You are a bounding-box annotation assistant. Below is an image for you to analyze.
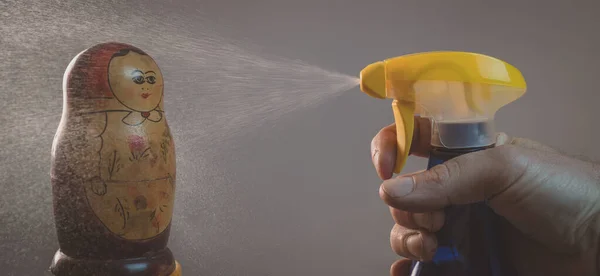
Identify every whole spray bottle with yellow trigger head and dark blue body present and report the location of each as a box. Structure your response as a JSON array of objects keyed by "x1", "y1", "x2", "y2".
[{"x1": 360, "y1": 52, "x2": 527, "y2": 276}]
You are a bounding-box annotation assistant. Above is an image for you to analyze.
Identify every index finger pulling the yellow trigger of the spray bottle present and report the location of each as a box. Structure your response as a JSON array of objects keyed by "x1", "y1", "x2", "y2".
[{"x1": 371, "y1": 116, "x2": 431, "y2": 180}]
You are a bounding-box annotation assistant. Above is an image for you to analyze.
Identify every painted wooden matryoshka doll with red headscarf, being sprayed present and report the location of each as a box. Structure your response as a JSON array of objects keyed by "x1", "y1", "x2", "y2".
[{"x1": 50, "y1": 43, "x2": 181, "y2": 276}]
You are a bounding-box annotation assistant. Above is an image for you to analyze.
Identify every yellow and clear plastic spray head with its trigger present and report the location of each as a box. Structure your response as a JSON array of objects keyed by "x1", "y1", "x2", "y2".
[{"x1": 360, "y1": 52, "x2": 527, "y2": 173}]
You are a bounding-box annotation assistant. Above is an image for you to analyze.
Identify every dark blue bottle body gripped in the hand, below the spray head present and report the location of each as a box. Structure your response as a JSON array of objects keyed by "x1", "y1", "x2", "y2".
[{"x1": 411, "y1": 147, "x2": 517, "y2": 276}]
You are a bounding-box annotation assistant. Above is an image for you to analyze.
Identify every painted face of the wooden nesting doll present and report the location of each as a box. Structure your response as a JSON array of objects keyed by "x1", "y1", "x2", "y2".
[{"x1": 108, "y1": 50, "x2": 164, "y2": 112}]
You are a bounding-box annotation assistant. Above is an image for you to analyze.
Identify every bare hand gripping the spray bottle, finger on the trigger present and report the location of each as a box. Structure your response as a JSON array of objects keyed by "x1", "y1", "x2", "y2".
[{"x1": 371, "y1": 117, "x2": 600, "y2": 276}]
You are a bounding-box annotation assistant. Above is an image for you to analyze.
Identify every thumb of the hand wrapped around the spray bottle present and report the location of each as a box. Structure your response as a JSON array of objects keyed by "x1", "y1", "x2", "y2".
[{"x1": 379, "y1": 145, "x2": 527, "y2": 212}]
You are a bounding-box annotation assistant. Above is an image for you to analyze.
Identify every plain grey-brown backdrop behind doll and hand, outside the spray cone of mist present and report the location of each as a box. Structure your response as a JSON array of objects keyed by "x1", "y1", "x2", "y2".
[{"x1": 0, "y1": 0, "x2": 600, "y2": 276}]
